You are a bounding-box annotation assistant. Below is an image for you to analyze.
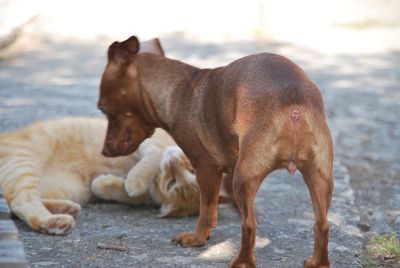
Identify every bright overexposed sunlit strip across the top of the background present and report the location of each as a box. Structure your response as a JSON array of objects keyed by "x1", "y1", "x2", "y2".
[{"x1": 0, "y1": 0, "x2": 400, "y2": 53}]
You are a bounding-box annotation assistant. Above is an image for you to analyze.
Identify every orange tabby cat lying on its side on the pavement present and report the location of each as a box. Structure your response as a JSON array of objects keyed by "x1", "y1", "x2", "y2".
[{"x1": 0, "y1": 118, "x2": 199, "y2": 235}]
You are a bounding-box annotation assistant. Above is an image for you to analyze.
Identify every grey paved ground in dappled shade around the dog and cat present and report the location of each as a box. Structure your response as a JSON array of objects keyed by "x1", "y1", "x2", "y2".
[{"x1": 0, "y1": 35, "x2": 400, "y2": 267}]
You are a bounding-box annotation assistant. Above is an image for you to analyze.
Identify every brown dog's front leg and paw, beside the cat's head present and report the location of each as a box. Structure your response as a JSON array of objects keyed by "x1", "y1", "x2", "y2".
[{"x1": 172, "y1": 166, "x2": 222, "y2": 247}]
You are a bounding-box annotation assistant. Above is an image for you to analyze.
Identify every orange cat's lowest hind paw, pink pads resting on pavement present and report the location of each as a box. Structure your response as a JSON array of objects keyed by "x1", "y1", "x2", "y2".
[{"x1": 40, "y1": 214, "x2": 75, "y2": 235}]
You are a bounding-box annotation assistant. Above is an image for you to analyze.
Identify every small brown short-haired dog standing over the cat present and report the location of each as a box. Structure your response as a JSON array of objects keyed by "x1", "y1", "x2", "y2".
[{"x1": 98, "y1": 36, "x2": 333, "y2": 267}]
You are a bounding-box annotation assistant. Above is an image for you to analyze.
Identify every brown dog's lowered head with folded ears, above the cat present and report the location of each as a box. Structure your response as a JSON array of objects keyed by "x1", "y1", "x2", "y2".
[{"x1": 98, "y1": 36, "x2": 164, "y2": 157}]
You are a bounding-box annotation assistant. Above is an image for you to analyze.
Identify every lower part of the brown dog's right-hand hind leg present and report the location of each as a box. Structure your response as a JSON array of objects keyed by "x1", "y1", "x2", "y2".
[{"x1": 301, "y1": 161, "x2": 333, "y2": 268}]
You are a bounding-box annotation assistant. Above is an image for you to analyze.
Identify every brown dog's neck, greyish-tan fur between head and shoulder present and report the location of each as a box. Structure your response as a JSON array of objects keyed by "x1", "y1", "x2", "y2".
[{"x1": 138, "y1": 53, "x2": 205, "y2": 129}]
